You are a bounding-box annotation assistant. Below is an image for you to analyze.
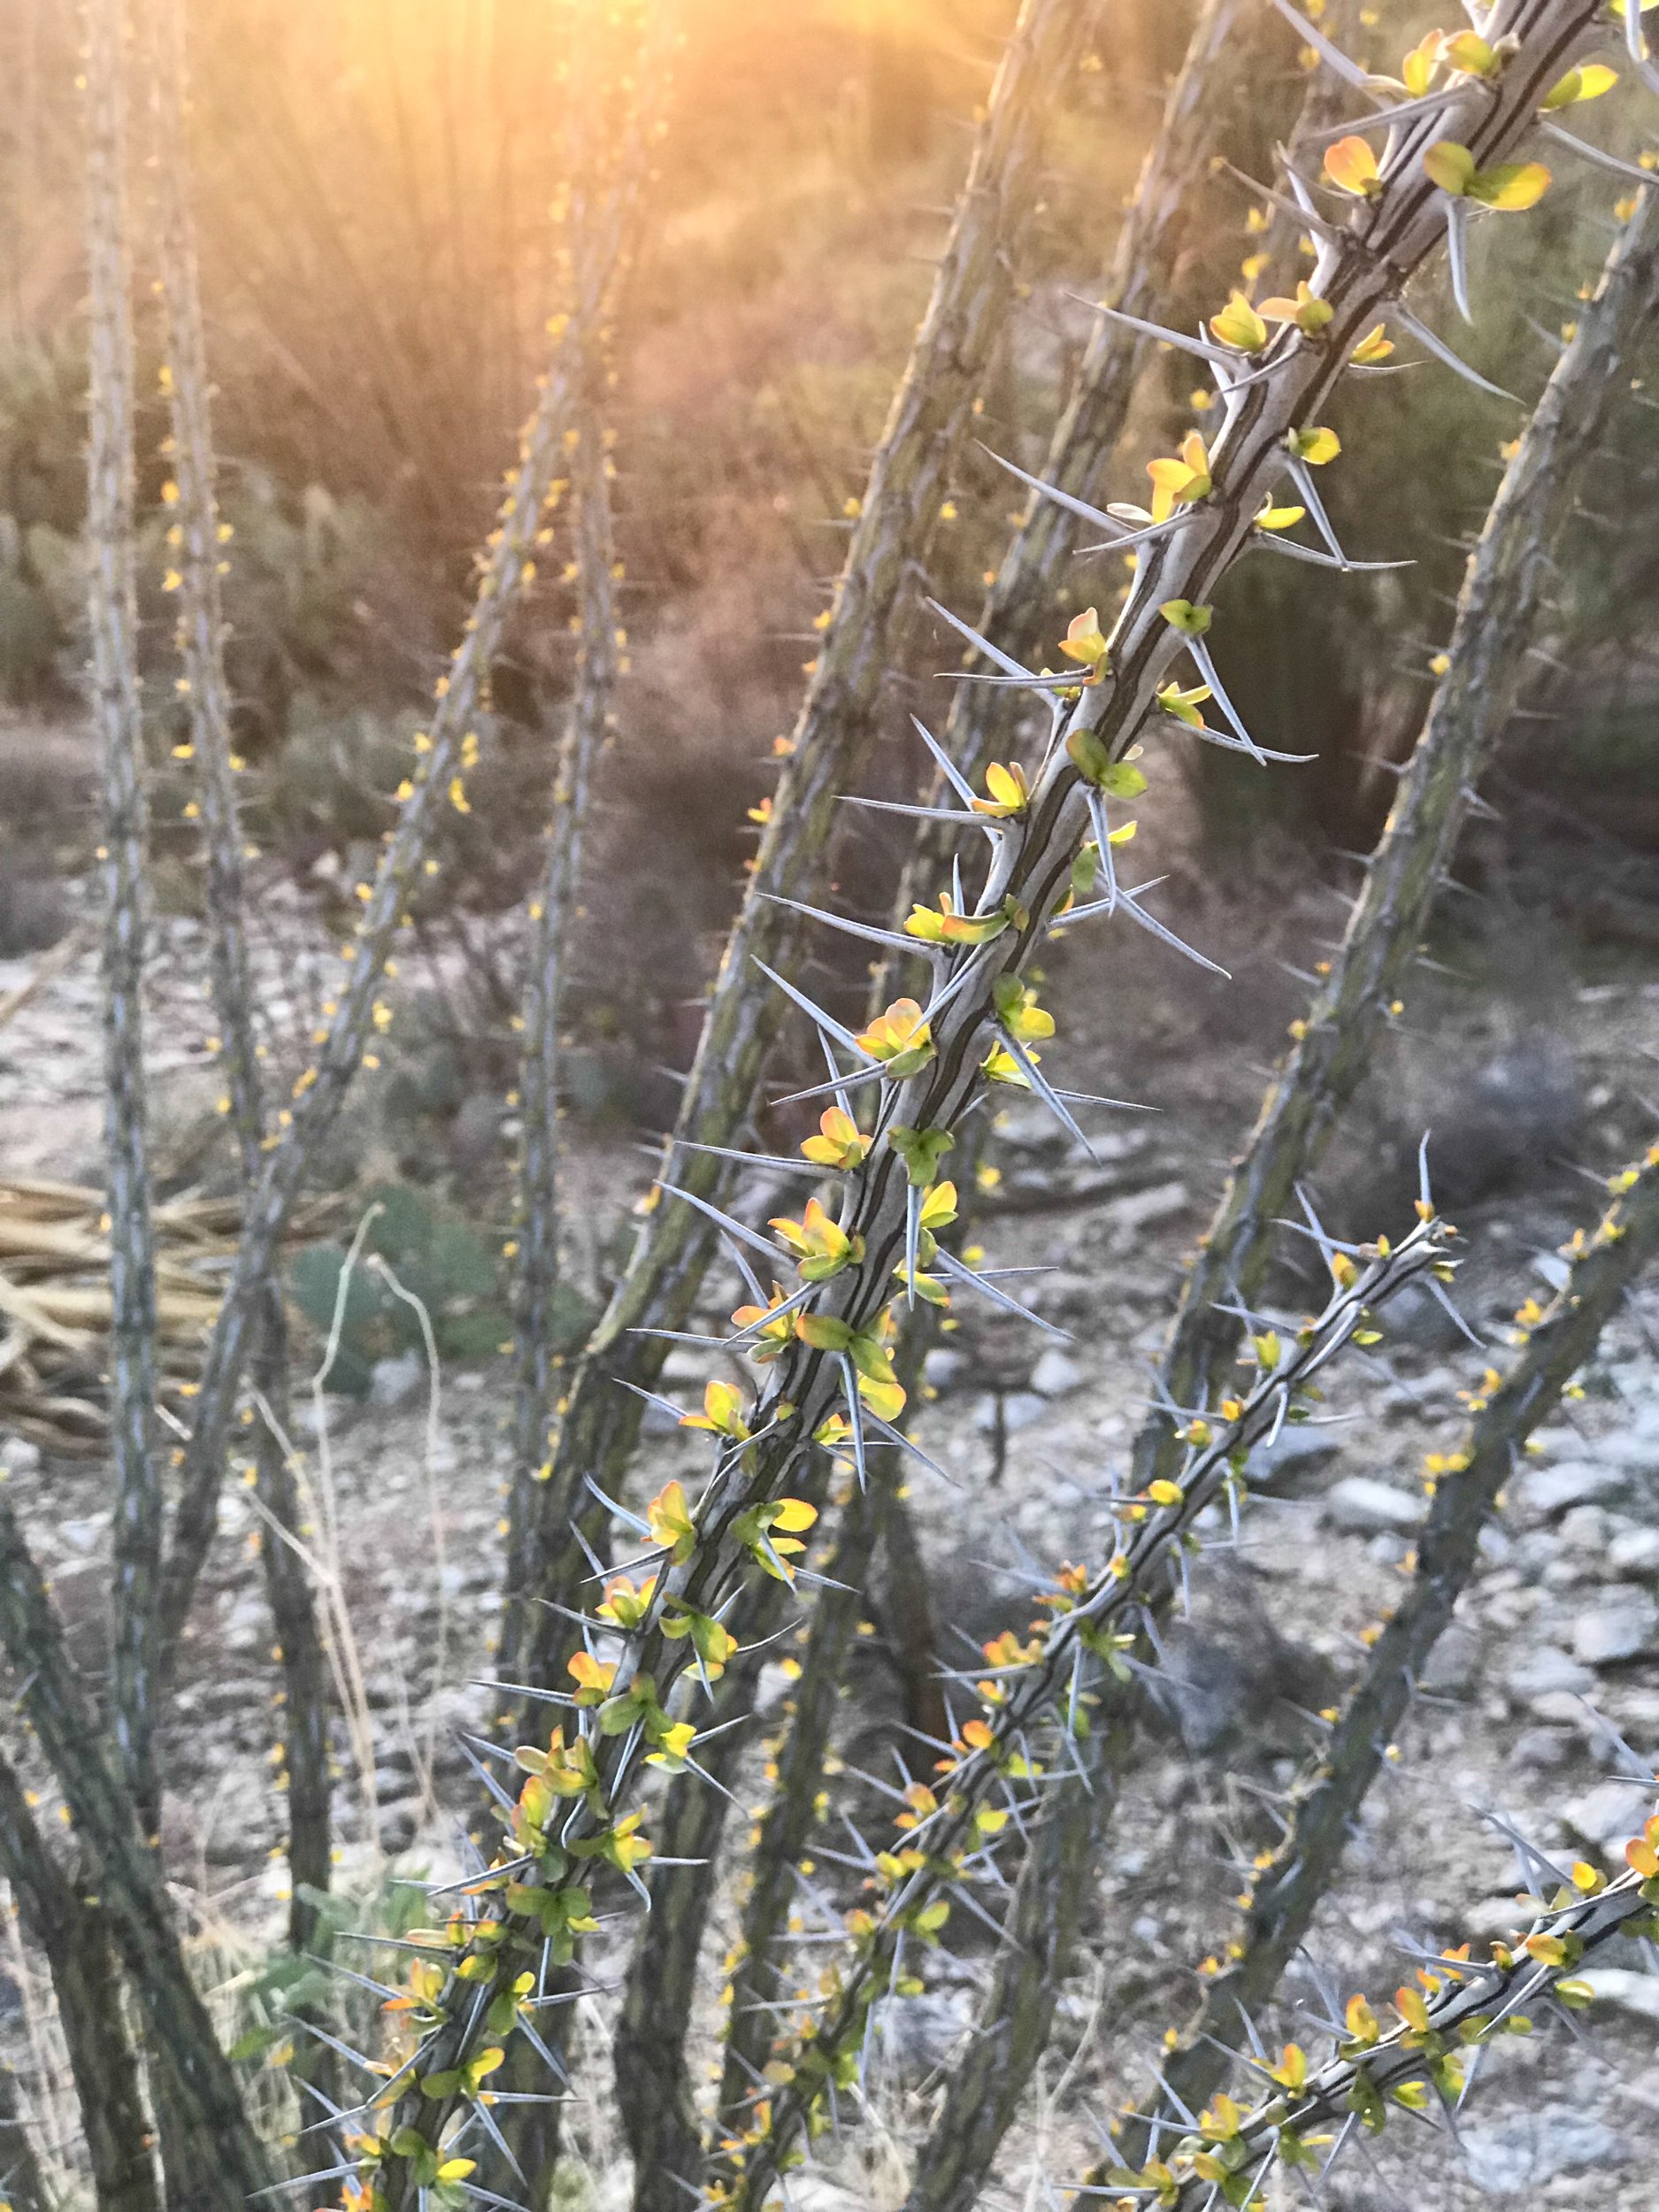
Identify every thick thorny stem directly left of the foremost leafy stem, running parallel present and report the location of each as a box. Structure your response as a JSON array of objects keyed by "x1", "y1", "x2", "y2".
[{"x1": 500, "y1": 0, "x2": 1110, "y2": 1686}]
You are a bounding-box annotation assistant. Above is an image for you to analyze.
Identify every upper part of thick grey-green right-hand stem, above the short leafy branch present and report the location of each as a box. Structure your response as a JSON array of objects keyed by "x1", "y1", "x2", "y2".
[{"x1": 1135, "y1": 177, "x2": 1659, "y2": 1478}]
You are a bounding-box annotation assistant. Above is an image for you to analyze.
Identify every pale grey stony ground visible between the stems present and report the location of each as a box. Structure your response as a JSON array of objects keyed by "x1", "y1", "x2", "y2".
[{"x1": 0, "y1": 889, "x2": 1659, "y2": 2212}]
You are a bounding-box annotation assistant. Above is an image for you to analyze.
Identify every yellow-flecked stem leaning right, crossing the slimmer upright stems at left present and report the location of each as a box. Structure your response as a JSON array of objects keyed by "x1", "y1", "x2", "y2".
[{"x1": 162, "y1": 8, "x2": 664, "y2": 1657}]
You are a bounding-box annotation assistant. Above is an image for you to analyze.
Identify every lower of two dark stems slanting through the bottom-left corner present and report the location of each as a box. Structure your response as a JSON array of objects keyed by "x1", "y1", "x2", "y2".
[{"x1": 0, "y1": 1752, "x2": 162, "y2": 2212}]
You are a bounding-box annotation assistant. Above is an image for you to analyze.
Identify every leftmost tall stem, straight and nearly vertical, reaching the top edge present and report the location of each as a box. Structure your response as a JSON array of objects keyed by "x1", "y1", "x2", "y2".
[{"x1": 87, "y1": 0, "x2": 162, "y2": 1827}]
